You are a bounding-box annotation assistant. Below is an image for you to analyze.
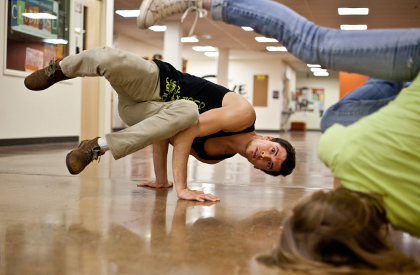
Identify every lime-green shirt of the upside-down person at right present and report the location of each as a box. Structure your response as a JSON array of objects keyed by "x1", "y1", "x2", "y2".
[{"x1": 318, "y1": 74, "x2": 420, "y2": 237}]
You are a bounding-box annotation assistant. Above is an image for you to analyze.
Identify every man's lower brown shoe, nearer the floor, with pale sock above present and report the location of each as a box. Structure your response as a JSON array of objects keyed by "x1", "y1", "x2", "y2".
[{"x1": 66, "y1": 137, "x2": 104, "y2": 175}]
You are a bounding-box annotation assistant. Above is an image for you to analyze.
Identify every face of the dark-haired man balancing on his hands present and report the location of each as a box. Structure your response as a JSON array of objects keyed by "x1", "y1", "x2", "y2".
[{"x1": 245, "y1": 136, "x2": 287, "y2": 172}]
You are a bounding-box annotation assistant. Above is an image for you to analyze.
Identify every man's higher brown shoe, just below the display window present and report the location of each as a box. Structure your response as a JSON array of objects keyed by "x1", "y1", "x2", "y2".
[{"x1": 24, "y1": 59, "x2": 71, "y2": 91}]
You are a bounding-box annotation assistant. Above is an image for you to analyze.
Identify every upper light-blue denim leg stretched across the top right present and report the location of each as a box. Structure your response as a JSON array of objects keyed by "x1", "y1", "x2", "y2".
[{"x1": 211, "y1": 0, "x2": 420, "y2": 81}]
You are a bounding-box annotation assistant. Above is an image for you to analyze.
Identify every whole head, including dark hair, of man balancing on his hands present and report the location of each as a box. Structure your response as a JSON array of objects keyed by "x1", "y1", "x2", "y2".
[{"x1": 246, "y1": 136, "x2": 296, "y2": 176}]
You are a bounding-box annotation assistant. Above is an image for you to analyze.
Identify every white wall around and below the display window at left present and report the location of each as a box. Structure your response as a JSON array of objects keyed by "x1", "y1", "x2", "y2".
[{"x1": 0, "y1": 1, "x2": 81, "y2": 139}]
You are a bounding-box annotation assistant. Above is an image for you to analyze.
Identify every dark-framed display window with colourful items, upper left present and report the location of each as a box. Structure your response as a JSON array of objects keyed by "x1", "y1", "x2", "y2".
[{"x1": 6, "y1": 0, "x2": 70, "y2": 72}]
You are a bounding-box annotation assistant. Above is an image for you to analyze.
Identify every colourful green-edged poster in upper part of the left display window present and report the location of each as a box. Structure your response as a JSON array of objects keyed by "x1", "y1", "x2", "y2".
[{"x1": 10, "y1": 0, "x2": 59, "y2": 39}]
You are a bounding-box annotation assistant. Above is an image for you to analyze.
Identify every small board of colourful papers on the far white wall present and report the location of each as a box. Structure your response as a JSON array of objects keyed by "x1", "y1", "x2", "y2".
[{"x1": 292, "y1": 88, "x2": 325, "y2": 116}]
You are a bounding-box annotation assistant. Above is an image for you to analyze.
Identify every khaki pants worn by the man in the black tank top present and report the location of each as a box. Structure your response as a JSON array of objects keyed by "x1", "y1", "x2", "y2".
[{"x1": 61, "y1": 47, "x2": 199, "y2": 159}]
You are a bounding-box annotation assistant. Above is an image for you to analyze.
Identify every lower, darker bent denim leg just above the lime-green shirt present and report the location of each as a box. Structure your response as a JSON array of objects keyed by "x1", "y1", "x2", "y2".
[{"x1": 320, "y1": 78, "x2": 403, "y2": 132}]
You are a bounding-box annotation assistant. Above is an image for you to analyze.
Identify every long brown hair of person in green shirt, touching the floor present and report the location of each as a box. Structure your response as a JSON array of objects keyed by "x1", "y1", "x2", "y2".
[{"x1": 258, "y1": 188, "x2": 420, "y2": 273}]
